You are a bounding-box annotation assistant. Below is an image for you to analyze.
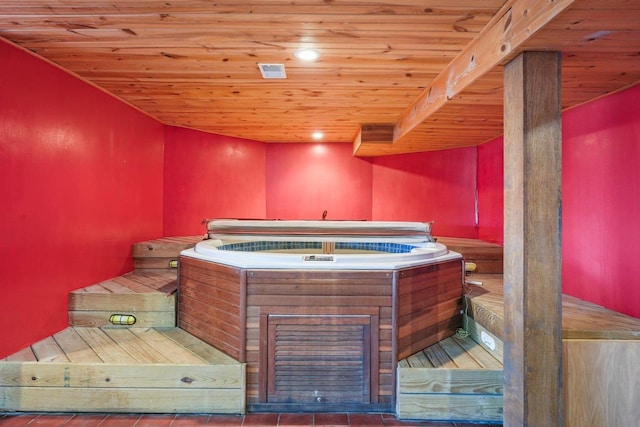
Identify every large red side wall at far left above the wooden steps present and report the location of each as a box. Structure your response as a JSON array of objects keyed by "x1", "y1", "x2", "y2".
[{"x1": 0, "y1": 41, "x2": 163, "y2": 358}]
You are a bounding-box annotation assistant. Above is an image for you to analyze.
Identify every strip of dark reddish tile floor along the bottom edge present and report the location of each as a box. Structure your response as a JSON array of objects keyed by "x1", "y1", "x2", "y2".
[{"x1": 0, "y1": 413, "x2": 500, "y2": 427}]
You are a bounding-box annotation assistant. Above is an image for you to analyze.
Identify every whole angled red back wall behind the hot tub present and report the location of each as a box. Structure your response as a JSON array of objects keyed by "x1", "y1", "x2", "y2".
[{"x1": 164, "y1": 139, "x2": 477, "y2": 232}]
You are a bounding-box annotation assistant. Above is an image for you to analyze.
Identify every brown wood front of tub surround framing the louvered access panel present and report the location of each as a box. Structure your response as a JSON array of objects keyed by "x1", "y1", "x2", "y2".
[{"x1": 246, "y1": 270, "x2": 395, "y2": 410}]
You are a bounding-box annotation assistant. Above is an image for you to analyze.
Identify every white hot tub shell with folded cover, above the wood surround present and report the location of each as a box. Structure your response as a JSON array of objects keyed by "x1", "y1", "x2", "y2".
[{"x1": 182, "y1": 220, "x2": 460, "y2": 270}]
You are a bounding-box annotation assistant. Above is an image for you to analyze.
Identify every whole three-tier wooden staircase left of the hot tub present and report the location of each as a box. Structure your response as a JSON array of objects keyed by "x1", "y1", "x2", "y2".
[{"x1": 0, "y1": 237, "x2": 246, "y2": 414}]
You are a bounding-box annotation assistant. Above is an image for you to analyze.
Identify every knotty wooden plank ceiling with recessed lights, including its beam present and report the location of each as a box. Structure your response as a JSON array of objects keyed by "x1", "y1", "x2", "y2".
[{"x1": 0, "y1": 0, "x2": 640, "y2": 156}]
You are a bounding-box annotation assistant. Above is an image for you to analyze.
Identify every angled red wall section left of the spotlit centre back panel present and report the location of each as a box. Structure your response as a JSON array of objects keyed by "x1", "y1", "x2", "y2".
[{"x1": 164, "y1": 126, "x2": 266, "y2": 236}]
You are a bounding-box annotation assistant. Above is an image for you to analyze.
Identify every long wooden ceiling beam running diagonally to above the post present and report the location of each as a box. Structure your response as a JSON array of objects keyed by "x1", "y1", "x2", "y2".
[{"x1": 354, "y1": 0, "x2": 576, "y2": 155}]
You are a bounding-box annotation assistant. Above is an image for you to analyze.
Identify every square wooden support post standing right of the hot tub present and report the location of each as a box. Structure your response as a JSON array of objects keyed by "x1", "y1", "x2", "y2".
[{"x1": 504, "y1": 52, "x2": 563, "y2": 426}]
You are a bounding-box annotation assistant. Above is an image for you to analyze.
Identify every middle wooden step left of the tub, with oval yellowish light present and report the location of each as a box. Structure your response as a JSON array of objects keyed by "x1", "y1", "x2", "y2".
[{"x1": 68, "y1": 271, "x2": 178, "y2": 328}]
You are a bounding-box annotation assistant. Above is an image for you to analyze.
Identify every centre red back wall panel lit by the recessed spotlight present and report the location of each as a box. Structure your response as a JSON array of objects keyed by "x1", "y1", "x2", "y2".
[{"x1": 266, "y1": 143, "x2": 371, "y2": 220}]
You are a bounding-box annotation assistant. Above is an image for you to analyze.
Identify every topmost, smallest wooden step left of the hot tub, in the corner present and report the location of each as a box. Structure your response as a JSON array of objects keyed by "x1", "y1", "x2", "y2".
[{"x1": 132, "y1": 236, "x2": 204, "y2": 271}]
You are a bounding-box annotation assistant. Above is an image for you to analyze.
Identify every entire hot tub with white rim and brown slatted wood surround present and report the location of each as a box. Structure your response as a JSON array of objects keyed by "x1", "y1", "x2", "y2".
[{"x1": 178, "y1": 221, "x2": 463, "y2": 412}]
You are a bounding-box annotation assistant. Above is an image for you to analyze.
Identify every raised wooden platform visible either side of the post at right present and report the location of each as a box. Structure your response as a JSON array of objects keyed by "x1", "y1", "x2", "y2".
[{"x1": 466, "y1": 275, "x2": 640, "y2": 427}]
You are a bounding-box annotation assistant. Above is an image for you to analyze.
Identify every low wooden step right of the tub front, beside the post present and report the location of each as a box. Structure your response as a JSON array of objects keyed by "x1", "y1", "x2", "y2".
[{"x1": 396, "y1": 336, "x2": 503, "y2": 422}]
